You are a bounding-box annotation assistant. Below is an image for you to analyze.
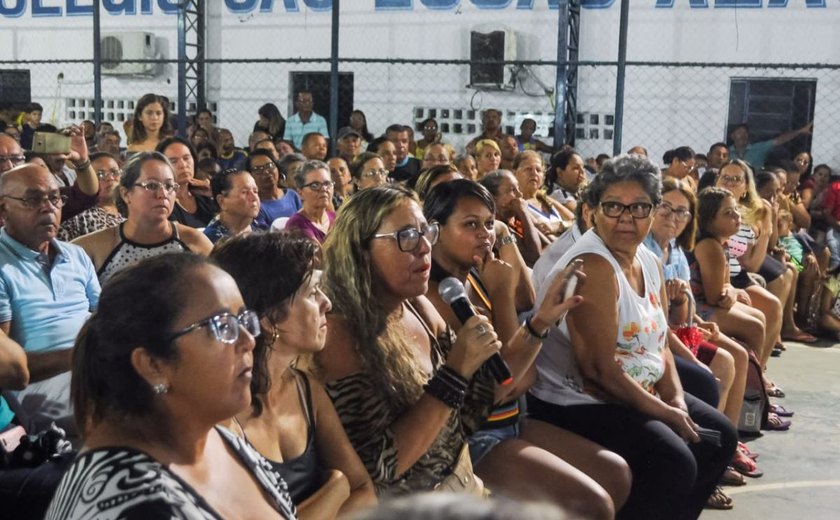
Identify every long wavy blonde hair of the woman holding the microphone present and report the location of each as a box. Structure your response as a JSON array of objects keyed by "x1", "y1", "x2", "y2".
[{"x1": 316, "y1": 186, "x2": 426, "y2": 410}]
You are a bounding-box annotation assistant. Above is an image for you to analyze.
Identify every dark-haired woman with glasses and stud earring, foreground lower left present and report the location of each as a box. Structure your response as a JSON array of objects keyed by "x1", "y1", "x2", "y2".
[{"x1": 46, "y1": 254, "x2": 296, "y2": 520}]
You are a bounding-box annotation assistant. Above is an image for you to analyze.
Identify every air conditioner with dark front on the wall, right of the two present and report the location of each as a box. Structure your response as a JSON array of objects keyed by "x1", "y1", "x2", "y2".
[{"x1": 469, "y1": 30, "x2": 516, "y2": 88}]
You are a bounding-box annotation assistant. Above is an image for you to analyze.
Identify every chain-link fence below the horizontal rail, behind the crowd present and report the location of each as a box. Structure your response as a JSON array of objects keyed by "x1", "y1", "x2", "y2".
[{"x1": 0, "y1": 55, "x2": 840, "y2": 163}]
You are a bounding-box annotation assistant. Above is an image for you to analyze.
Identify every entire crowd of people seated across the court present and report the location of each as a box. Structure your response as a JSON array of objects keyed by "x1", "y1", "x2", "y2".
[{"x1": 0, "y1": 92, "x2": 828, "y2": 519}]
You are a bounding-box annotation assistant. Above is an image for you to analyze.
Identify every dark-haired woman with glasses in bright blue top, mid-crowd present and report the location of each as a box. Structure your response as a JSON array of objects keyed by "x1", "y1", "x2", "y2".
[{"x1": 245, "y1": 150, "x2": 303, "y2": 230}]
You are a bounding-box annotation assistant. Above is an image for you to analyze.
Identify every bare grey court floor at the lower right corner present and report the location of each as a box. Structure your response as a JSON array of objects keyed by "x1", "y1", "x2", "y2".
[{"x1": 701, "y1": 341, "x2": 840, "y2": 520}]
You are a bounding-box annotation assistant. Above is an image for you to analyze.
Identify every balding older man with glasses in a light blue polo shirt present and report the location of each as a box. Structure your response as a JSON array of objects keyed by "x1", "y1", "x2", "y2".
[{"x1": 0, "y1": 160, "x2": 100, "y2": 437}]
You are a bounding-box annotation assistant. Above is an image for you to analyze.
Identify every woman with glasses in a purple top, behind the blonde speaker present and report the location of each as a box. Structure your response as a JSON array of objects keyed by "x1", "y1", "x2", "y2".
[{"x1": 286, "y1": 161, "x2": 335, "y2": 244}]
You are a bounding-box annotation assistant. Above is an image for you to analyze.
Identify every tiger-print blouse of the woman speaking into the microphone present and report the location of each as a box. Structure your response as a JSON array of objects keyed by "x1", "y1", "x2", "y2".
[{"x1": 326, "y1": 304, "x2": 496, "y2": 494}]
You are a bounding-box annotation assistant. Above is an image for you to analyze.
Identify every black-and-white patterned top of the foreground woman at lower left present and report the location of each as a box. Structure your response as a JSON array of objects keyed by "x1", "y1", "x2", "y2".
[{"x1": 45, "y1": 426, "x2": 297, "y2": 520}]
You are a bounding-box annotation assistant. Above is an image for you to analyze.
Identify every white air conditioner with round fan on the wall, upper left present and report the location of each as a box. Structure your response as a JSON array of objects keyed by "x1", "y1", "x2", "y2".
[{"x1": 99, "y1": 32, "x2": 157, "y2": 76}]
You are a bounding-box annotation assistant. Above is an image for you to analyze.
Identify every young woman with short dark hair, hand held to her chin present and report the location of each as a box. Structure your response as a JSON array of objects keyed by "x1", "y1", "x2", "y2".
[{"x1": 423, "y1": 177, "x2": 630, "y2": 518}]
